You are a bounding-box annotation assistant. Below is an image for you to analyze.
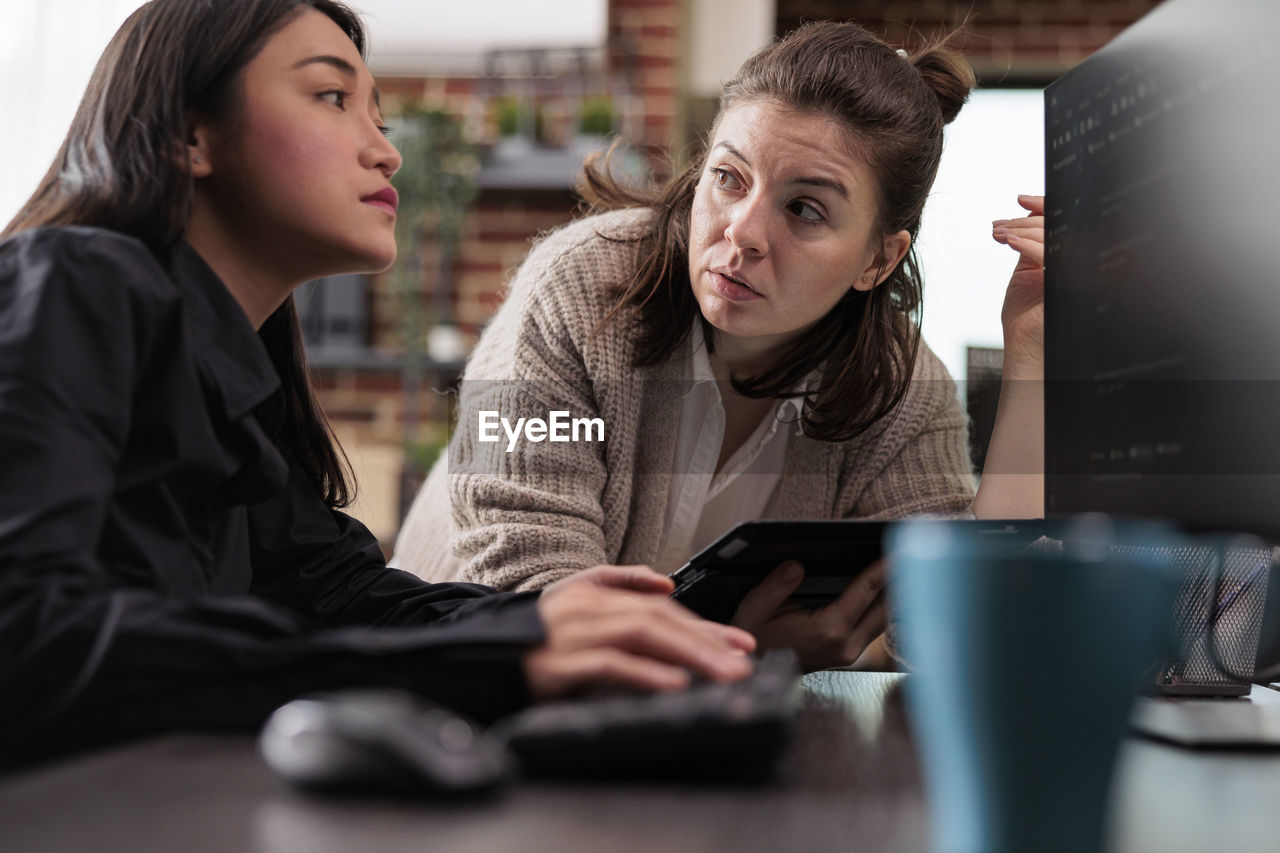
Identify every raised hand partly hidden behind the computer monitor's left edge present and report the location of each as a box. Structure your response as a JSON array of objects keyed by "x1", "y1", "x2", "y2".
[{"x1": 991, "y1": 196, "x2": 1044, "y2": 379}]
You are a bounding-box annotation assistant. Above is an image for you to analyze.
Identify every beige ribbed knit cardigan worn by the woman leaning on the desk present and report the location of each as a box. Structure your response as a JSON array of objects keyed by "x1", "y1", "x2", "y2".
[{"x1": 393, "y1": 210, "x2": 974, "y2": 589}]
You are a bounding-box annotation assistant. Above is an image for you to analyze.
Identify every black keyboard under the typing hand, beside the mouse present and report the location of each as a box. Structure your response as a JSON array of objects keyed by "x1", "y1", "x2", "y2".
[{"x1": 492, "y1": 649, "x2": 800, "y2": 781}]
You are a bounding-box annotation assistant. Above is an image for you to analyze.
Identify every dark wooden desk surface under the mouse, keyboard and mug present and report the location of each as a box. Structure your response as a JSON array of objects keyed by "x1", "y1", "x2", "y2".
[{"x1": 0, "y1": 672, "x2": 1280, "y2": 853}]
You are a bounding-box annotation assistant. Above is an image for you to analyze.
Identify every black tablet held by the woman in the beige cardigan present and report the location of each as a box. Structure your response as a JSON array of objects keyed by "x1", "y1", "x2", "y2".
[{"x1": 671, "y1": 519, "x2": 1042, "y2": 622}]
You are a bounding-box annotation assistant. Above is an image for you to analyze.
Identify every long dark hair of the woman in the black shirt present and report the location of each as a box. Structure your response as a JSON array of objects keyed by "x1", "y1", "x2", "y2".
[{"x1": 0, "y1": 0, "x2": 365, "y2": 506}]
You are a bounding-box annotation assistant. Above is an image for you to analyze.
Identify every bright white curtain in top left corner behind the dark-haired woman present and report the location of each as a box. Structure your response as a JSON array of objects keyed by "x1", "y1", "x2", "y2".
[{"x1": 0, "y1": 0, "x2": 142, "y2": 225}]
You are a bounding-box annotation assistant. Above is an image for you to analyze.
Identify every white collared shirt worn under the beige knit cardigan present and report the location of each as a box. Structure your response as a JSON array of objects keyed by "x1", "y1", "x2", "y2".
[{"x1": 655, "y1": 318, "x2": 801, "y2": 573}]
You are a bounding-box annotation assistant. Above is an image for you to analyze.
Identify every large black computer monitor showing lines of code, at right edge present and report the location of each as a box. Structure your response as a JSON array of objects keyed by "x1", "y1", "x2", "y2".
[{"x1": 1044, "y1": 0, "x2": 1280, "y2": 540}]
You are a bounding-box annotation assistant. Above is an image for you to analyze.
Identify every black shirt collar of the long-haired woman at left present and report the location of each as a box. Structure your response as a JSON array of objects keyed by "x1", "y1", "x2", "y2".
[{"x1": 168, "y1": 242, "x2": 280, "y2": 420}]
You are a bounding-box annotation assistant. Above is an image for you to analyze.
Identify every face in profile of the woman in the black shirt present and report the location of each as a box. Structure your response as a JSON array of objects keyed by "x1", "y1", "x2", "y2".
[{"x1": 192, "y1": 9, "x2": 401, "y2": 280}]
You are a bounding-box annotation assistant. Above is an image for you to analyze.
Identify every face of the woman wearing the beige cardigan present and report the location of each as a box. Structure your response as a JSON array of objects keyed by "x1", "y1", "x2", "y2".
[{"x1": 689, "y1": 101, "x2": 910, "y2": 343}]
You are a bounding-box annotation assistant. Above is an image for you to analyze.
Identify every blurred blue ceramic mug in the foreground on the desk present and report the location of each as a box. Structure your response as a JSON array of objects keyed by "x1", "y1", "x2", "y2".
[{"x1": 888, "y1": 516, "x2": 1178, "y2": 853}]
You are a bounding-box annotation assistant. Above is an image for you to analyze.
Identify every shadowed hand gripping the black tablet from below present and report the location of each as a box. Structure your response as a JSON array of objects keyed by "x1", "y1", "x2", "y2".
[{"x1": 733, "y1": 560, "x2": 888, "y2": 670}]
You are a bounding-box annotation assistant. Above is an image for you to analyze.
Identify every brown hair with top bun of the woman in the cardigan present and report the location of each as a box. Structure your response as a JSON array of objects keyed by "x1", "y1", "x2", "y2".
[{"x1": 581, "y1": 22, "x2": 974, "y2": 441}]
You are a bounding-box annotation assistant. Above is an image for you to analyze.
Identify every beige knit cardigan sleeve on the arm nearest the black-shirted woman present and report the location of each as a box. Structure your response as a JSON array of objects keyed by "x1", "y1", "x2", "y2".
[{"x1": 442, "y1": 220, "x2": 640, "y2": 589}]
